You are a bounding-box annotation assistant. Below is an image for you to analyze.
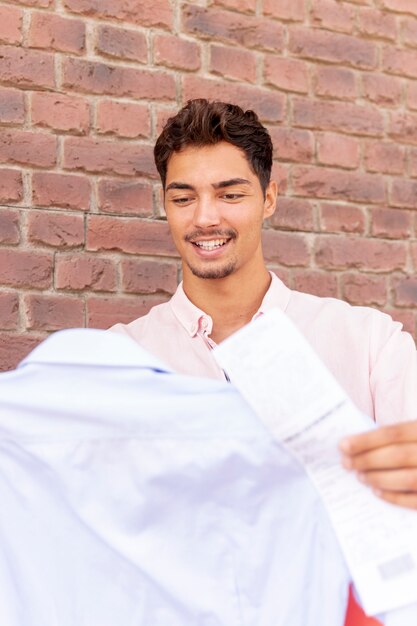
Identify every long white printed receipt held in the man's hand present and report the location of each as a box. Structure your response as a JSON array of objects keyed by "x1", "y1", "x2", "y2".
[{"x1": 214, "y1": 310, "x2": 417, "y2": 626}]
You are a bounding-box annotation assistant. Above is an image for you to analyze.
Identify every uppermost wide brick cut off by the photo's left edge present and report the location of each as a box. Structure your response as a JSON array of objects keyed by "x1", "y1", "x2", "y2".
[{"x1": 0, "y1": 46, "x2": 55, "y2": 88}]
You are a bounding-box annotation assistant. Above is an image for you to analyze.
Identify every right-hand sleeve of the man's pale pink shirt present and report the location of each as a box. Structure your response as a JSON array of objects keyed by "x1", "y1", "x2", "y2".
[{"x1": 370, "y1": 314, "x2": 417, "y2": 425}]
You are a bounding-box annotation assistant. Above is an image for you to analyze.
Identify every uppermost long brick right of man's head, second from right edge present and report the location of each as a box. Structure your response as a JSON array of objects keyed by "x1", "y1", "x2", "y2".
[{"x1": 289, "y1": 26, "x2": 377, "y2": 69}]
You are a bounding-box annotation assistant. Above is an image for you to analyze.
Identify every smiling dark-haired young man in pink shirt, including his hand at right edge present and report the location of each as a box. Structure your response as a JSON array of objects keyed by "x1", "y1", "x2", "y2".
[{"x1": 112, "y1": 100, "x2": 417, "y2": 509}]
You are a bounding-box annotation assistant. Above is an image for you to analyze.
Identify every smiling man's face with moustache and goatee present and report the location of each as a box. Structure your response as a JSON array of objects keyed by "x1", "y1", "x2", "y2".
[{"x1": 165, "y1": 141, "x2": 276, "y2": 279}]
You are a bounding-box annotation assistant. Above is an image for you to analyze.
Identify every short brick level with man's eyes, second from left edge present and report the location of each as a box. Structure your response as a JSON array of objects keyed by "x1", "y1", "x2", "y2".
[{"x1": 32, "y1": 172, "x2": 91, "y2": 211}]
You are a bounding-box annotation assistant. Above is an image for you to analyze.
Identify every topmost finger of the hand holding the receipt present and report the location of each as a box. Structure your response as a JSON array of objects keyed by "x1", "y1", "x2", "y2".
[{"x1": 340, "y1": 421, "x2": 417, "y2": 456}]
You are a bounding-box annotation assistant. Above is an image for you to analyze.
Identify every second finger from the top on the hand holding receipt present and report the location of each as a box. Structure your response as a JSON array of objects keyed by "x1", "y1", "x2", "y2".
[{"x1": 342, "y1": 443, "x2": 417, "y2": 472}]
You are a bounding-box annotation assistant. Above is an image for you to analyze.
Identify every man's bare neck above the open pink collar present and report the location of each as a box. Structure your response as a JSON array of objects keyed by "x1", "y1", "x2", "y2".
[{"x1": 183, "y1": 266, "x2": 271, "y2": 343}]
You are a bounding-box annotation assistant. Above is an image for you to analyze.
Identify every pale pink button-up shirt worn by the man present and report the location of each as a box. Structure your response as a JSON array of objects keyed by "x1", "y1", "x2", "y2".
[{"x1": 111, "y1": 274, "x2": 417, "y2": 424}]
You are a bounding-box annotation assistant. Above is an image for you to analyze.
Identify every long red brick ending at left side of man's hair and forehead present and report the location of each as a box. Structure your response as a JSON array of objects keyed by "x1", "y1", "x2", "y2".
[{"x1": 64, "y1": 137, "x2": 156, "y2": 177}]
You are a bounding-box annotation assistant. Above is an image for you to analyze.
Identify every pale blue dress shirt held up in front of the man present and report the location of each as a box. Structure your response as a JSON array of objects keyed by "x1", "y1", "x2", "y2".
[{"x1": 0, "y1": 330, "x2": 349, "y2": 626}]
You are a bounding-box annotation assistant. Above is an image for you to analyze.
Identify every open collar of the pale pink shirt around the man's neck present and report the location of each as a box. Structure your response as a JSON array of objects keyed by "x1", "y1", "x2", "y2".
[{"x1": 170, "y1": 272, "x2": 291, "y2": 337}]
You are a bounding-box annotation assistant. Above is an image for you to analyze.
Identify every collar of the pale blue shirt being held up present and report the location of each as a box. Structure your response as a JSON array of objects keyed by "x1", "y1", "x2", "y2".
[{"x1": 19, "y1": 328, "x2": 172, "y2": 372}]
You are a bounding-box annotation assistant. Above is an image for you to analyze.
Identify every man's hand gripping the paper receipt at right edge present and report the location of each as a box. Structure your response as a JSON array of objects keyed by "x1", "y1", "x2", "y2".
[{"x1": 340, "y1": 422, "x2": 417, "y2": 509}]
